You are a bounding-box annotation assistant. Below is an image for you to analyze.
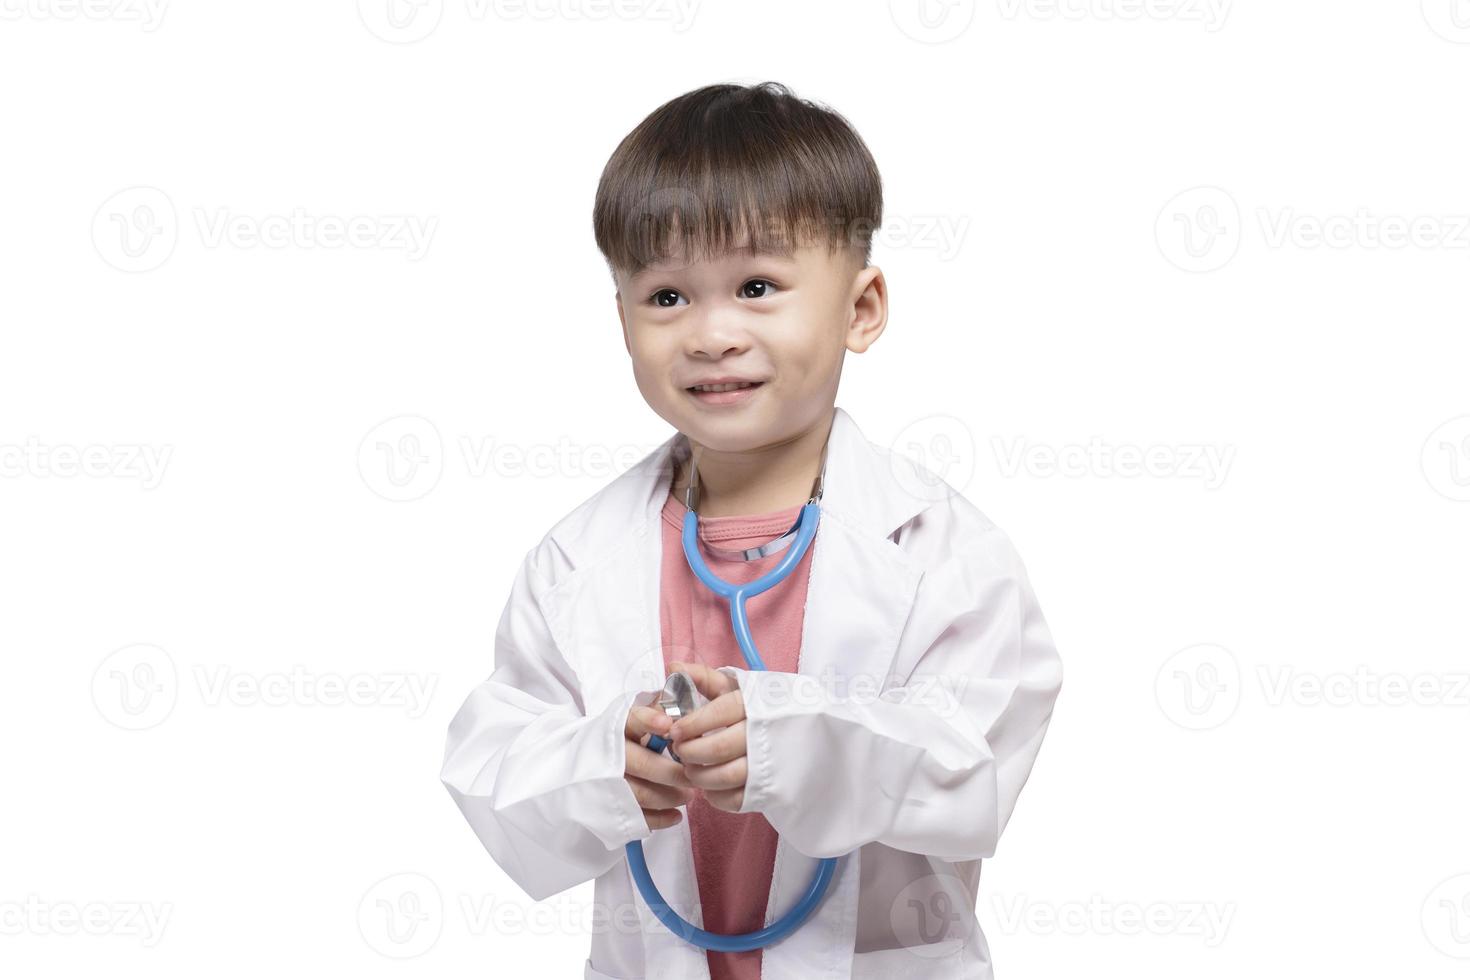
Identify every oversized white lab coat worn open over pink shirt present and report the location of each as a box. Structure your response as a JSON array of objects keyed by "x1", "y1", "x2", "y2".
[{"x1": 441, "y1": 407, "x2": 1061, "y2": 980}]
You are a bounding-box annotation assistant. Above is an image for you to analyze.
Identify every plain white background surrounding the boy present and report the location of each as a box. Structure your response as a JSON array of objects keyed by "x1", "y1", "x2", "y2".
[{"x1": 0, "y1": 0, "x2": 1470, "y2": 980}]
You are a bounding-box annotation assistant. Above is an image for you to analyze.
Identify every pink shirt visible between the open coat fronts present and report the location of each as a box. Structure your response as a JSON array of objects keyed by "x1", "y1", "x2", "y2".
[{"x1": 659, "y1": 492, "x2": 817, "y2": 980}]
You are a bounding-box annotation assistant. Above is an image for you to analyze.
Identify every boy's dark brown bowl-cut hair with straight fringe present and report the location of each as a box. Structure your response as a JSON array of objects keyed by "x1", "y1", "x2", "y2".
[{"x1": 592, "y1": 82, "x2": 883, "y2": 276}]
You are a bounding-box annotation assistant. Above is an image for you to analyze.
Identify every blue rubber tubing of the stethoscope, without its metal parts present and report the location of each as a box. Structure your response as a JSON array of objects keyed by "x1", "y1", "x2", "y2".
[{"x1": 623, "y1": 501, "x2": 836, "y2": 952}]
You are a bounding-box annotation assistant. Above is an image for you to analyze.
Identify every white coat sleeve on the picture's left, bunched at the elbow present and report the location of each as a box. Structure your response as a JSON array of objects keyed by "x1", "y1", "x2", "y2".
[{"x1": 440, "y1": 545, "x2": 651, "y2": 901}]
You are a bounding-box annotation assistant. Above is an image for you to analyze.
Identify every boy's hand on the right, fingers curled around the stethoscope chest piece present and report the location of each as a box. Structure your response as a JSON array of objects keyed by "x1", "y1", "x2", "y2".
[{"x1": 666, "y1": 661, "x2": 747, "y2": 813}]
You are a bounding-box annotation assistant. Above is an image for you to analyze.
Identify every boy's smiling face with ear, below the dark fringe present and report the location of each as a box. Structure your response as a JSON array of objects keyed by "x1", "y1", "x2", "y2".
[{"x1": 617, "y1": 235, "x2": 888, "y2": 453}]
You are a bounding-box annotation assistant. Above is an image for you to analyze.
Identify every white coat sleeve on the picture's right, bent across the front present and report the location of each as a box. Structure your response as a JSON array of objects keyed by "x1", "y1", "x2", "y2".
[{"x1": 722, "y1": 497, "x2": 1061, "y2": 861}]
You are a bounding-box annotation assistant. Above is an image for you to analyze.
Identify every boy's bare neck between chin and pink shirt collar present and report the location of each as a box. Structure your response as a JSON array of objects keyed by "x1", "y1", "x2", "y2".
[{"x1": 673, "y1": 413, "x2": 835, "y2": 517}]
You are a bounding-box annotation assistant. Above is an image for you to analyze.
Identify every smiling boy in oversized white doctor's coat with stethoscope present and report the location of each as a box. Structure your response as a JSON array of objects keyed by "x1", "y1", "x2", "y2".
[{"x1": 442, "y1": 82, "x2": 1061, "y2": 980}]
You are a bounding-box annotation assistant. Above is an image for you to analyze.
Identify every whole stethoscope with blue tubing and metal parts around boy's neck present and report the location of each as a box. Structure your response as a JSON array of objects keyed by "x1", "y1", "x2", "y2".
[{"x1": 623, "y1": 434, "x2": 836, "y2": 952}]
